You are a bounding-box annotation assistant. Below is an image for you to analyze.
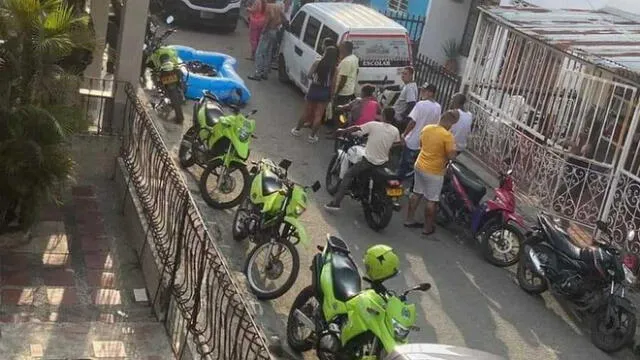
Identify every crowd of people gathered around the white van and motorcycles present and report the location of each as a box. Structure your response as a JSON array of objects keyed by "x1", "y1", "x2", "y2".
[{"x1": 249, "y1": 0, "x2": 472, "y2": 236}]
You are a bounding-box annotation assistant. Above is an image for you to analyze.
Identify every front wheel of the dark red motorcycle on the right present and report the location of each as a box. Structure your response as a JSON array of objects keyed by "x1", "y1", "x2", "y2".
[{"x1": 482, "y1": 223, "x2": 524, "y2": 267}]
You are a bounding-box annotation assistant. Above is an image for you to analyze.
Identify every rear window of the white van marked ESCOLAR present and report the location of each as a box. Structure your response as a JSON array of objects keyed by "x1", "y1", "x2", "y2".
[{"x1": 349, "y1": 34, "x2": 411, "y2": 67}]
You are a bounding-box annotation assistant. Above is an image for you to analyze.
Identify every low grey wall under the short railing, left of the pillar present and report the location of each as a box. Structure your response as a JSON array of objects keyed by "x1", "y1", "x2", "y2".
[{"x1": 71, "y1": 134, "x2": 122, "y2": 182}]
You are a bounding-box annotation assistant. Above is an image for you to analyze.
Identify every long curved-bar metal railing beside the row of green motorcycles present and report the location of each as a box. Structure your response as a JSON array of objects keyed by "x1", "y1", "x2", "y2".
[{"x1": 121, "y1": 84, "x2": 270, "y2": 360}]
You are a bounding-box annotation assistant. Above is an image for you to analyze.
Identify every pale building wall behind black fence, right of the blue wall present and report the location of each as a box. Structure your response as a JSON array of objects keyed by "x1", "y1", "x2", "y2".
[{"x1": 420, "y1": 0, "x2": 471, "y2": 64}]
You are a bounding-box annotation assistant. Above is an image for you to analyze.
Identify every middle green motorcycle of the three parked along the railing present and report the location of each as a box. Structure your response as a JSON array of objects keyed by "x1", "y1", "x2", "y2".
[{"x1": 233, "y1": 159, "x2": 320, "y2": 300}]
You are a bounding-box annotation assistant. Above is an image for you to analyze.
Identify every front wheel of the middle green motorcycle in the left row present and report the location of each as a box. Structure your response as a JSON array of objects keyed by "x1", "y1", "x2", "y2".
[{"x1": 245, "y1": 232, "x2": 300, "y2": 300}]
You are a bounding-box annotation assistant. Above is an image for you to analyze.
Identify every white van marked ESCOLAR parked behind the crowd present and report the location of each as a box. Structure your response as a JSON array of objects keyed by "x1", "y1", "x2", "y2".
[{"x1": 278, "y1": 2, "x2": 412, "y2": 93}]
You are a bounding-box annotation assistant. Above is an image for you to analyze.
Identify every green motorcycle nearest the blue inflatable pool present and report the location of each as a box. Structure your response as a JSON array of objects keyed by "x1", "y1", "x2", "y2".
[{"x1": 188, "y1": 91, "x2": 257, "y2": 209}]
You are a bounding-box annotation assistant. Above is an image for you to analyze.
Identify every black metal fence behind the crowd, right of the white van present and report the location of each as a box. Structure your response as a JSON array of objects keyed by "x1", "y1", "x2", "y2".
[{"x1": 413, "y1": 54, "x2": 462, "y2": 110}]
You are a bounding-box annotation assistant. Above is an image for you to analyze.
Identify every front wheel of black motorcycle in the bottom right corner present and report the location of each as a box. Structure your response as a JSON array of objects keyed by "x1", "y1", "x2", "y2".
[{"x1": 591, "y1": 305, "x2": 636, "y2": 353}]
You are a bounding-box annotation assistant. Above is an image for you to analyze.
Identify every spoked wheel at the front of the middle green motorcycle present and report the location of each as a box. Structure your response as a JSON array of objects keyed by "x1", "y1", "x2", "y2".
[{"x1": 244, "y1": 235, "x2": 300, "y2": 300}]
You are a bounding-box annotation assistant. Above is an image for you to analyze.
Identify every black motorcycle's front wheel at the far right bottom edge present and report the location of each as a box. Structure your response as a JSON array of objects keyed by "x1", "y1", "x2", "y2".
[{"x1": 591, "y1": 306, "x2": 636, "y2": 353}]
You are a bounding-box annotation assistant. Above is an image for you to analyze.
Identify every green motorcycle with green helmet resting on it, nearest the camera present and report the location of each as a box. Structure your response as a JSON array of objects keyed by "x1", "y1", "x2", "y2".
[{"x1": 287, "y1": 236, "x2": 431, "y2": 360}]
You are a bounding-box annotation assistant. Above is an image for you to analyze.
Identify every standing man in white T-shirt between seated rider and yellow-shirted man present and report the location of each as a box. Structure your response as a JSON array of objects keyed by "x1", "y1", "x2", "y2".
[{"x1": 398, "y1": 84, "x2": 442, "y2": 179}]
